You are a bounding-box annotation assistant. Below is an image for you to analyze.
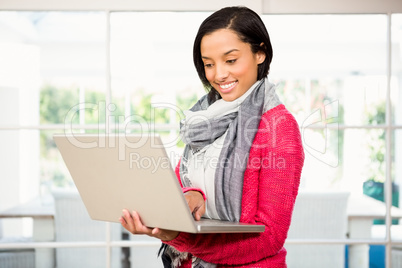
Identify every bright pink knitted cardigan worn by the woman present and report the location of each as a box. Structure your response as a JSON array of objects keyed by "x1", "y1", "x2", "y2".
[{"x1": 163, "y1": 104, "x2": 304, "y2": 268}]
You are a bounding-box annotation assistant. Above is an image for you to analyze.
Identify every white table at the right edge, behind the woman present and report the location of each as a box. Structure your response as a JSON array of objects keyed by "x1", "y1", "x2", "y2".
[{"x1": 347, "y1": 194, "x2": 402, "y2": 268}]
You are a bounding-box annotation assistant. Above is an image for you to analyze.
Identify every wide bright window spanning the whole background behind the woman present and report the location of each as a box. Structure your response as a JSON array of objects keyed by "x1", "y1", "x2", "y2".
[{"x1": 0, "y1": 5, "x2": 402, "y2": 265}]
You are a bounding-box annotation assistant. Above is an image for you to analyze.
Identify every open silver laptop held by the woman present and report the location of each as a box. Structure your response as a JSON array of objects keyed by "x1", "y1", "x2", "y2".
[{"x1": 53, "y1": 134, "x2": 265, "y2": 233}]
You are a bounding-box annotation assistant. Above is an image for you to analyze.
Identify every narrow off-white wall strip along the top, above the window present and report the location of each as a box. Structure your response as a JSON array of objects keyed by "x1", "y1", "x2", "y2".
[{"x1": 0, "y1": 0, "x2": 402, "y2": 13}]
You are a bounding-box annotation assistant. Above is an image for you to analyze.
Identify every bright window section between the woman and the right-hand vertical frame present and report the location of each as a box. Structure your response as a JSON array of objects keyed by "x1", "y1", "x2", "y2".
[{"x1": 264, "y1": 15, "x2": 387, "y2": 193}]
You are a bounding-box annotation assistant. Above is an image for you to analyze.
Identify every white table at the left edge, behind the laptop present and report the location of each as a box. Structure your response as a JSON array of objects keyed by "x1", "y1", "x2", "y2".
[{"x1": 0, "y1": 198, "x2": 55, "y2": 268}]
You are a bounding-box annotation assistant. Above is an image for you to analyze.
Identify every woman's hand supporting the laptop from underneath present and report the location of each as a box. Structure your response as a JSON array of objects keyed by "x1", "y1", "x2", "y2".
[{"x1": 119, "y1": 209, "x2": 179, "y2": 241}]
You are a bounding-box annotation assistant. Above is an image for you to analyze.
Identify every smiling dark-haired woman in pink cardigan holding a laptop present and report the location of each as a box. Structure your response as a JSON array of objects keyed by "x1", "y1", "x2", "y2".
[{"x1": 120, "y1": 7, "x2": 304, "y2": 268}]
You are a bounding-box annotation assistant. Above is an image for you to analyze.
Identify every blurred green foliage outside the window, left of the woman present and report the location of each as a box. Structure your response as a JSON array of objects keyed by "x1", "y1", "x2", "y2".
[{"x1": 39, "y1": 85, "x2": 197, "y2": 187}]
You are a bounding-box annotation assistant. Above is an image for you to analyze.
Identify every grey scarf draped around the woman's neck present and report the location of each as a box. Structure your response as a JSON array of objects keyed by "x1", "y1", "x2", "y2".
[{"x1": 180, "y1": 77, "x2": 265, "y2": 222}]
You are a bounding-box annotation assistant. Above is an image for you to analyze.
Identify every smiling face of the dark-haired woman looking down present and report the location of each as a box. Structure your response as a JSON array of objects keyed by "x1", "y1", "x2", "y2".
[{"x1": 201, "y1": 29, "x2": 265, "y2": 101}]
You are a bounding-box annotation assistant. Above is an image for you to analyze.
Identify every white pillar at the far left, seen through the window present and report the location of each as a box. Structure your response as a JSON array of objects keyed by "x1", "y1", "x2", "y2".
[{"x1": 0, "y1": 43, "x2": 40, "y2": 238}]
